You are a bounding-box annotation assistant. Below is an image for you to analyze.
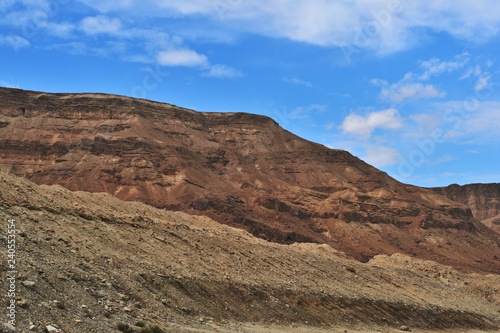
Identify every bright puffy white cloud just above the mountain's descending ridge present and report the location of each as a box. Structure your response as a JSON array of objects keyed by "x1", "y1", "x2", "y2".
[{"x1": 340, "y1": 109, "x2": 403, "y2": 139}]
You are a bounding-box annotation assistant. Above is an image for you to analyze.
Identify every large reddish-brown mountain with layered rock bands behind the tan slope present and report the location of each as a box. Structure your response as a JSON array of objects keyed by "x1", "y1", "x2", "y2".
[{"x1": 0, "y1": 88, "x2": 500, "y2": 273}]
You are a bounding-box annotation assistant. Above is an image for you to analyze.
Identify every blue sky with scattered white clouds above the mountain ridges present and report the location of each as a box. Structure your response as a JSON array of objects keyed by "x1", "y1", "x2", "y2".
[{"x1": 0, "y1": 0, "x2": 500, "y2": 186}]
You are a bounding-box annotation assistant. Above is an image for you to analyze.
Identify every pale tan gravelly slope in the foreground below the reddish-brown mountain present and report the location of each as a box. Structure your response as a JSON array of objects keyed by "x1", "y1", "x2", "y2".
[{"x1": 0, "y1": 173, "x2": 500, "y2": 333}]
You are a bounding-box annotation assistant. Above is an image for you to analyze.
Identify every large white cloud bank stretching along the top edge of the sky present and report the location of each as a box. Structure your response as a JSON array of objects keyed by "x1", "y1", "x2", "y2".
[{"x1": 75, "y1": 0, "x2": 500, "y2": 53}]
